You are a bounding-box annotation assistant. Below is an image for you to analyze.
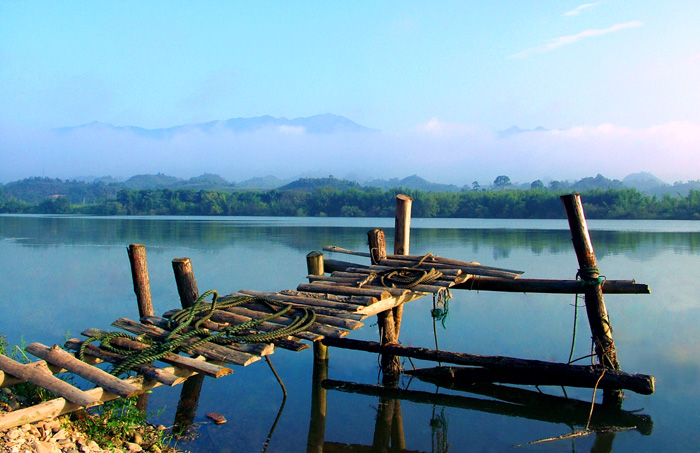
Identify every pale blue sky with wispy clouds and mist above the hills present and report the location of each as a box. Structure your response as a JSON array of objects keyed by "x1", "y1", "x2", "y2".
[{"x1": 0, "y1": 0, "x2": 700, "y2": 185}]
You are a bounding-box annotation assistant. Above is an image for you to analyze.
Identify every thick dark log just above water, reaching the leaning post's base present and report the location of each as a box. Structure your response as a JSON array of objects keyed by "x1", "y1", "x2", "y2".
[{"x1": 323, "y1": 339, "x2": 654, "y2": 395}]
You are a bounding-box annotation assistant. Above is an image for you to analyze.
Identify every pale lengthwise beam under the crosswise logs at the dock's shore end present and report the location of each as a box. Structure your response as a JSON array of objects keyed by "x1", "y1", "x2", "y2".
[{"x1": 0, "y1": 368, "x2": 178, "y2": 430}]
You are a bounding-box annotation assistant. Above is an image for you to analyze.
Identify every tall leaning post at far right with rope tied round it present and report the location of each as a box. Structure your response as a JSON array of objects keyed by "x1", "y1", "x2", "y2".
[{"x1": 561, "y1": 194, "x2": 622, "y2": 402}]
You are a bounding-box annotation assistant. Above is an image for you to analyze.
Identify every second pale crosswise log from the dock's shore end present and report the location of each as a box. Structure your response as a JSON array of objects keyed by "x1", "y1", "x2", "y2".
[{"x1": 25, "y1": 343, "x2": 139, "y2": 398}]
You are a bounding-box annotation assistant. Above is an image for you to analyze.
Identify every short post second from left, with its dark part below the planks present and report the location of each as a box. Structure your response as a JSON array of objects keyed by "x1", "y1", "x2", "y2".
[{"x1": 173, "y1": 258, "x2": 204, "y2": 432}]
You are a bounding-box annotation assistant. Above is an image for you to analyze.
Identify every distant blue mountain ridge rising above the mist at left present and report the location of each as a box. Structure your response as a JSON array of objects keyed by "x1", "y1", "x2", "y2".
[{"x1": 55, "y1": 113, "x2": 376, "y2": 139}]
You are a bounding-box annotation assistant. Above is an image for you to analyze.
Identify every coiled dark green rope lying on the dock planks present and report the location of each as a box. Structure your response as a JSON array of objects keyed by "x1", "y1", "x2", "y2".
[{"x1": 79, "y1": 290, "x2": 316, "y2": 376}]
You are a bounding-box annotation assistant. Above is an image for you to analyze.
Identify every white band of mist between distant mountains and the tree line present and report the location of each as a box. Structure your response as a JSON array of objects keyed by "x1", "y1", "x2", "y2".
[{"x1": 0, "y1": 119, "x2": 700, "y2": 186}]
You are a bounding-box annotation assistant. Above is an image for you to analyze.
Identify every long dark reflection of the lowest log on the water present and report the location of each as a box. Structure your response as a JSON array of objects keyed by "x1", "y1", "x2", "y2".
[{"x1": 323, "y1": 379, "x2": 653, "y2": 435}]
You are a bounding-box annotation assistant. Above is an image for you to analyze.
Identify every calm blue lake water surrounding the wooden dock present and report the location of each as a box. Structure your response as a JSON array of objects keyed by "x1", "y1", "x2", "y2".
[{"x1": 0, "y1": 216, "x2": 700, "y2": 452}]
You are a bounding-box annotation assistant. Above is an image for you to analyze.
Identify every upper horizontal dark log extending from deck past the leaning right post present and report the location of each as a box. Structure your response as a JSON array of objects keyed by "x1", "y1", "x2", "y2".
[{"x1": 453, "y1": 276, "x2": 651, "y2": 294}]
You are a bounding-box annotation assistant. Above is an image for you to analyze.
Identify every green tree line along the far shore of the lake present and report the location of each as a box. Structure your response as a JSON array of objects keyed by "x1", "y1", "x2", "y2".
[{"x1": 0, "y1": 186, "x2": 700, "y2": 220}]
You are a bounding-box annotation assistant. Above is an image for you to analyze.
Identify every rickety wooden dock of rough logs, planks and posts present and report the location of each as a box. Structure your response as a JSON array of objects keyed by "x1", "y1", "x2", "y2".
[{"x1": 0, "y1": 192, "x2": 654, "y2": 440}]
